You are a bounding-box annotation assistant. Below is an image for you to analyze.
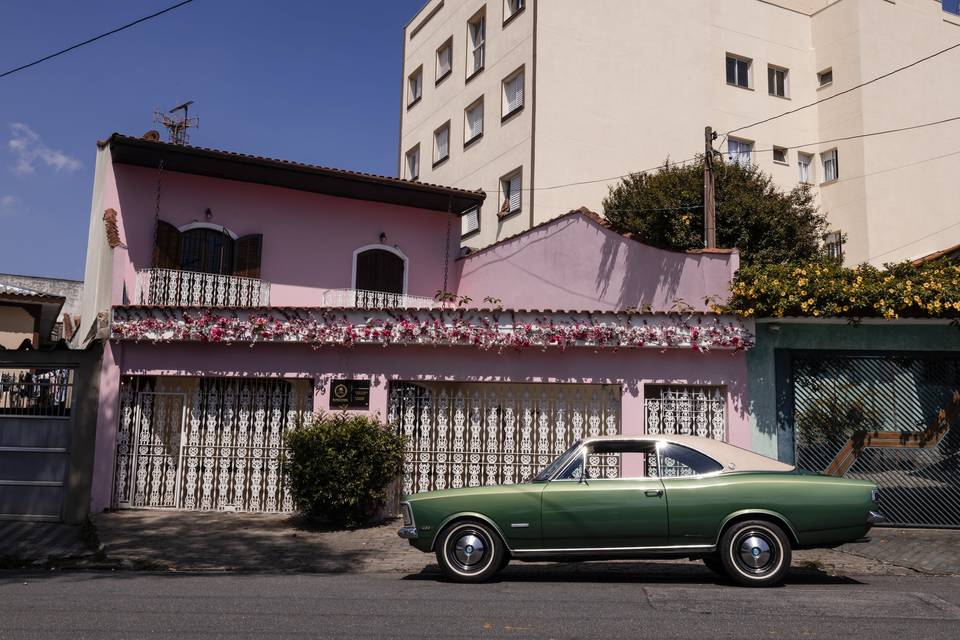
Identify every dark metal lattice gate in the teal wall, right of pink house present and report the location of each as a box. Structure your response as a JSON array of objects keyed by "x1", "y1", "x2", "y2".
[{"x1": 791, "y1": 354, "x2": 960, "y2": 527}]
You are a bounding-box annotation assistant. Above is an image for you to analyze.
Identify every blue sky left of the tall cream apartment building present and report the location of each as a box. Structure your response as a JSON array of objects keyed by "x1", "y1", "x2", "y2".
[{"x1": 0, "y1": 0, "x2": 422, "y2": 279}]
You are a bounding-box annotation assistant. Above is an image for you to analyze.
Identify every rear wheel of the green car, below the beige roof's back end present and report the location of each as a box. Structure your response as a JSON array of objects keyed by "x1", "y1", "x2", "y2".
[{"x1": 719, "y1": 520, "x2": 791, "y2": 587}]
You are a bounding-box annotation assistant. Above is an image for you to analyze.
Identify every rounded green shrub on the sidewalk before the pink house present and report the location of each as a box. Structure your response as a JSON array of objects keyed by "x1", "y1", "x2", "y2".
[{"x1": 283, "y1": 414, "x2": 405, "y2": 526}]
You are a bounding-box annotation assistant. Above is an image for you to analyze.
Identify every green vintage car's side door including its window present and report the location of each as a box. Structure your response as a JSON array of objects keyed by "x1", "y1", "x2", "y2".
[{"x1": 541, "y1": 441, "x2": 668, "y2": 550}]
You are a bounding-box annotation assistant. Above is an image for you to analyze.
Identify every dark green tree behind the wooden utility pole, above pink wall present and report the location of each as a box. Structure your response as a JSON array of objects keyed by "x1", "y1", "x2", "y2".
[{"x1": 603, "y1": 156, "x2": 827, "y2": 263}]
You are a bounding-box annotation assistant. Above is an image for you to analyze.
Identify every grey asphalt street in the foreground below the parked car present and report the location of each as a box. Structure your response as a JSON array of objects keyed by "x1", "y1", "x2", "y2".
[{"x1": 0, "y1": 570, "x2": 960, "y2": 640}]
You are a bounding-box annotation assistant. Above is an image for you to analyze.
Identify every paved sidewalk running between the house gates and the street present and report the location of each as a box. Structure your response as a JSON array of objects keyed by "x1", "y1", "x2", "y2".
[{"x1": 0, "y1": 510, "x2": 960, "y2": 576}]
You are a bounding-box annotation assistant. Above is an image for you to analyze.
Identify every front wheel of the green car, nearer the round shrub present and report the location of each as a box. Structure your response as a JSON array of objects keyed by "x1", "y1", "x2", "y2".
[{"x1": 437, "y1": 520, "x2": 509, "y2": 582}]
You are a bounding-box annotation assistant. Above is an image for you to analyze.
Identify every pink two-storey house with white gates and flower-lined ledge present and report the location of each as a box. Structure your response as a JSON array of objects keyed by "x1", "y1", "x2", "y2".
[{"x1": 77, "y1": 135, "x2": 753, "y2": 511}]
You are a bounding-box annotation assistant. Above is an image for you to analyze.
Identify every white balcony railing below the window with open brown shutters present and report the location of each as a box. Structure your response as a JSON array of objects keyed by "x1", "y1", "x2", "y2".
[{"x1": 137, "y1": 269, "x2": 270, "y2": 307}]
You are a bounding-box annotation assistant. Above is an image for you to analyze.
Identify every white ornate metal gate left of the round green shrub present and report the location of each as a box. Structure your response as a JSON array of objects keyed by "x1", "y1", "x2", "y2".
[{"x1": 114, "y1": 377, "x2": 312, "y2": 511}]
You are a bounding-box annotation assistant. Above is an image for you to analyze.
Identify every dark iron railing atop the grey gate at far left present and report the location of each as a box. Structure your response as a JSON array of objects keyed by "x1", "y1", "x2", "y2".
[{"x1": 0, "y1": 368, "x2": 73, "y2": 418}]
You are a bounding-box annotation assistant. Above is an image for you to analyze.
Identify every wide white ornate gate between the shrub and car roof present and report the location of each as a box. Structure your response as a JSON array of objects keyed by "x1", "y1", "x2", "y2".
[{"x1": 388, "y1": 382, "x2": 621, "y2": 494}]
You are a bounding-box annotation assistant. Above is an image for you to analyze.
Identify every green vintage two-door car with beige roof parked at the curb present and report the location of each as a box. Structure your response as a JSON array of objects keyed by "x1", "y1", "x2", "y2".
[{"x1": 399, "y1": 436, "x2": 882, "y2": 586}]
